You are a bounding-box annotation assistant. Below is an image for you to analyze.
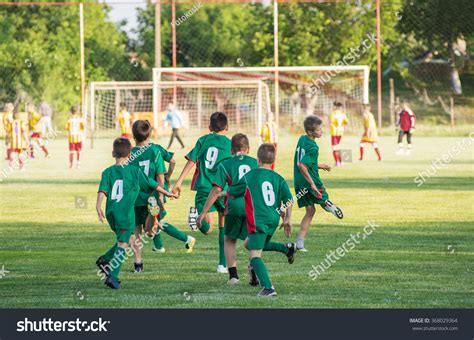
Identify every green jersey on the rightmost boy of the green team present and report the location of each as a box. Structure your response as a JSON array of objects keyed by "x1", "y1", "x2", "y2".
[{"x1": 293, "y1": 135, "x2": 321, "y2": 190}]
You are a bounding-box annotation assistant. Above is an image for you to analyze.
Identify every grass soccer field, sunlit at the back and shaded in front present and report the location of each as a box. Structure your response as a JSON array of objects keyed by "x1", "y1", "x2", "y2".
[{"x1": 0, "y1": 135, "x2": 474, "y2": 308}]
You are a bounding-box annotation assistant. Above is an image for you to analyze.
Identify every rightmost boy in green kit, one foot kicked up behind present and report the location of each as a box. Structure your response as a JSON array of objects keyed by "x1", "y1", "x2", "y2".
[{"x1": 293, "y1": 115, "x2": 343, "y2": 251}]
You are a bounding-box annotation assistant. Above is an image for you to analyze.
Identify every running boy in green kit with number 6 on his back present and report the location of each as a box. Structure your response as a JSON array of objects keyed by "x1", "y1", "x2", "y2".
[{"x1": 227, "y1": 144, "x2": 296, "y2": 297}]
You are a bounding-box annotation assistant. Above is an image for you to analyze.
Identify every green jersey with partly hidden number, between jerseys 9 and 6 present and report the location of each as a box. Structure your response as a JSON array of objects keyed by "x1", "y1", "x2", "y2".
[{"x1": 212, "y1": 155, "x2": 258, "y2": 216}]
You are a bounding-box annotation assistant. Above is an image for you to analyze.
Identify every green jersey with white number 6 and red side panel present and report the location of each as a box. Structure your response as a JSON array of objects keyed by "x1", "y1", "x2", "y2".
[{"x1": 228, "y1": 168, "x2": 292, "y2": 235}]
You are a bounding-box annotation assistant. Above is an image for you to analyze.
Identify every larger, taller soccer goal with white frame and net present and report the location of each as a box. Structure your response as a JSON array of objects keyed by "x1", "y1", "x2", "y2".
[{"x1": 153, "y1": 65, "x2": 369, "y2": 135}]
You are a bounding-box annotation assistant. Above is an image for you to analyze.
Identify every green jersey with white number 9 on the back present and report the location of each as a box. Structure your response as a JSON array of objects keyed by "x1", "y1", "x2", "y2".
[{"x1": 186, "y1": 133, "x2": 232, "y2": 192}]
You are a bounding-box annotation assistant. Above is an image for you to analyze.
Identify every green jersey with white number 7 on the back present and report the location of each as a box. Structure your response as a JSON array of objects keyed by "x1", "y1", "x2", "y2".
[{"x1": 129, "y1": 143, "x2": 166, "y2": 207}]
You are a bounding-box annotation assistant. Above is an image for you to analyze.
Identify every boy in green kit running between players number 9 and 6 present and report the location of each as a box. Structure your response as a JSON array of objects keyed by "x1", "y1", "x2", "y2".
[{"x1": 197, "y1": 133, "x2": 258, "y2": 284}]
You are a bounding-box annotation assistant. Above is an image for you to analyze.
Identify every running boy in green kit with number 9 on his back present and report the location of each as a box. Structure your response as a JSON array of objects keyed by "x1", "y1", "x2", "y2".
[{"x1": 172, "y1": 112, "x2": 232, "y2": 273}]
